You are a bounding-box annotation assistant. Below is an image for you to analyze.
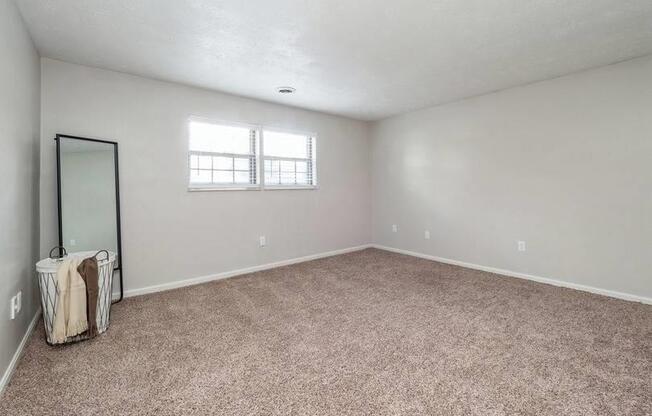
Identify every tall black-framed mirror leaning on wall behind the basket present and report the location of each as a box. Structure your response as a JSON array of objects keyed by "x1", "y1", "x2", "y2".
[{"x1": 55, "y1": 134, "x2": 123, "y2": 301}]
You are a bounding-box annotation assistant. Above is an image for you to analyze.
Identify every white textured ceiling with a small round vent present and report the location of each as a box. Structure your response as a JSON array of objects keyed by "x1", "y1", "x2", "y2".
[{"x1": 17, "y1": 0, "x2": 652, "y2": 120}]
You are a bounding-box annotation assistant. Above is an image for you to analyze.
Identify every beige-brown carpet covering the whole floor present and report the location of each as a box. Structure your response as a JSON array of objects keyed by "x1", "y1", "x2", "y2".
[{"x1": 0, "y1": 250, "x2": 652, "y2": 416}]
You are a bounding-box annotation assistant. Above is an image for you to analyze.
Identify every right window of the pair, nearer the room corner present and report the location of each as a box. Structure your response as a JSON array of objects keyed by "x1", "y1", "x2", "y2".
[{"x1": 263, "y1": 130, "x2": 317, "y2": 188}]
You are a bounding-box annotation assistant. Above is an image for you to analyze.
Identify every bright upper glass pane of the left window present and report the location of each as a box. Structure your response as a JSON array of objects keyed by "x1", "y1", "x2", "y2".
[{"x1": 190, "y1": 121, "x2": 252, "y2": 154}]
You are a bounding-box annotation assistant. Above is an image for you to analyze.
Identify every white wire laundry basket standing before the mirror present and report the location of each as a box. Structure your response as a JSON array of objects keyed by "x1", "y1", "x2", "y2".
[{"x1": 36, "y1": 250, "x2": 115, "y2": 345}]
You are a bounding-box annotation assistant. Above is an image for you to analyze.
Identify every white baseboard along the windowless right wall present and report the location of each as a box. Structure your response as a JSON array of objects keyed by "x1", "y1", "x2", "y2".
[{"x1": 371, "y1": 244, "x2": 652, "y2": 305}]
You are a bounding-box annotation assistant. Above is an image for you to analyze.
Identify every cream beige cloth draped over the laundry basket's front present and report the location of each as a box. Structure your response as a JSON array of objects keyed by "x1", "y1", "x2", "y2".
[{"x1": 52, "y1": 258, "x2": 88, "y2": 343}]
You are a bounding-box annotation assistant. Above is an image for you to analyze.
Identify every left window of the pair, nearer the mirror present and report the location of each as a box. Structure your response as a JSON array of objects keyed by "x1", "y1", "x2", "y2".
[{"x1": 188, "y1": 121, "x2": 259, "y2": 189}]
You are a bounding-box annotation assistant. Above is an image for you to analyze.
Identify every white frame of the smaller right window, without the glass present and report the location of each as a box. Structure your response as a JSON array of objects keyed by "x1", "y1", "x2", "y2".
[{"x1": 259, "y1": 126, "x2": 319, "y2": 191}]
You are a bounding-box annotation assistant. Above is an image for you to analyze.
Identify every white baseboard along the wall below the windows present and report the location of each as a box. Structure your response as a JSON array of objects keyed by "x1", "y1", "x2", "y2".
[{"x1": 113, "y1": 244, "x2": 371, "y2": 299}]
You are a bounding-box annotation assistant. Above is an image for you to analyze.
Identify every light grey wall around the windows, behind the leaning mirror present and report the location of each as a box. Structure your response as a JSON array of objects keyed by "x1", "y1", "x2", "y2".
[{"x1": 41, "y1": 59, "x2": 371, "y2": 289}]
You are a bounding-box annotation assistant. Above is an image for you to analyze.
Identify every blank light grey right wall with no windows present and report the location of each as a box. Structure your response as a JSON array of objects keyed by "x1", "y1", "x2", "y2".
[{"x1": 372, "y1": 57, "x2": 652, "y2": 298}]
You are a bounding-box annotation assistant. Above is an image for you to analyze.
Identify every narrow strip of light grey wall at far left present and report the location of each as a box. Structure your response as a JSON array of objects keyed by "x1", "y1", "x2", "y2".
[{"x1": 0, "y1": 0, "x2": 40, "y2": 388}]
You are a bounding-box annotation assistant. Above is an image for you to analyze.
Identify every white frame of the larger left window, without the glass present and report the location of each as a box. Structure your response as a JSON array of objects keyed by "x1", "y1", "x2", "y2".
[{"x1": 186, "y1": 116, "x2": 263, "y2": 192}]
